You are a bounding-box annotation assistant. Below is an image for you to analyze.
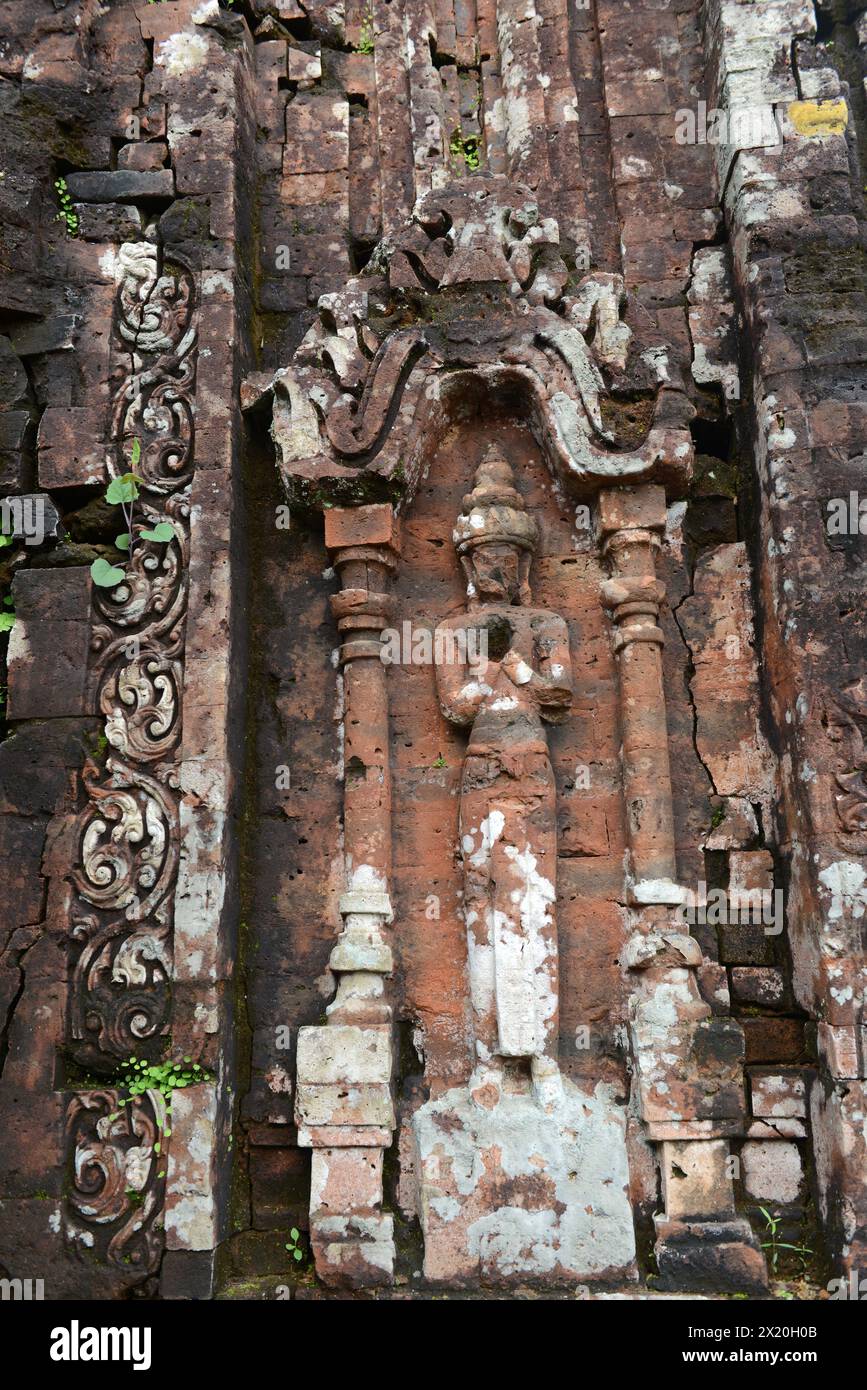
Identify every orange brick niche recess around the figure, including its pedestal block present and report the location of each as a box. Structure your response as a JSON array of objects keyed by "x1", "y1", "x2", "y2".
[{"x1": 388, "y1": 389, "x2": 635, "y2": 1284}]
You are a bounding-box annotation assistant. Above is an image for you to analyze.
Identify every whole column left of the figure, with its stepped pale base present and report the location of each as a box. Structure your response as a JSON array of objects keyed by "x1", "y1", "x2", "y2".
[{"x1": 296, "y1": 505, "x2": 397, "y2": 1286}]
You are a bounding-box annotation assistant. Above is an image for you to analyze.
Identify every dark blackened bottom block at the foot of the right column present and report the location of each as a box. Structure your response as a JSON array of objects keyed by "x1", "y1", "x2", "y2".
[{"x1": 654, "y1": 1216, "x2": 768, "y2": 1297}]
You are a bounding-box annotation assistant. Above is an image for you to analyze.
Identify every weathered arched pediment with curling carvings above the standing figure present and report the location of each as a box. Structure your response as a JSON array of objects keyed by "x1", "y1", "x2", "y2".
[{"x1": 253, "y1": 178, "x2": 692, "y2": 505}]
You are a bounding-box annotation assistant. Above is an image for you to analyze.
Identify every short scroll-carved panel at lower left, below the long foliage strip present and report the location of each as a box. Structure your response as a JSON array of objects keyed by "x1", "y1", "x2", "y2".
[{"x1": 67, "y1": 1090, "x2": 165, "y2": 1269}]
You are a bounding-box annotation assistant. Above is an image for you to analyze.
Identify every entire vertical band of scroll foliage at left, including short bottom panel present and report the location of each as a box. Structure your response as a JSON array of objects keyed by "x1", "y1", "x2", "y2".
[{"x1": 67, "y1": 240, "x2": 197, "y2": 1270}]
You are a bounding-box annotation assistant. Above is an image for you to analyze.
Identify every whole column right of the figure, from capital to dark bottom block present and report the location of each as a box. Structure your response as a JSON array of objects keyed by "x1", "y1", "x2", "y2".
[{"x1": 597, "y1": 484, "x2": 767, "y2": 1291}]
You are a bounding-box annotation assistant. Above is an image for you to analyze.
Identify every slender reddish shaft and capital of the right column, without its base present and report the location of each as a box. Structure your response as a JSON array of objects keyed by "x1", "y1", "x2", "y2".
[{"x1": 599, "y1": 484, "x2": 684, "y2": 904}]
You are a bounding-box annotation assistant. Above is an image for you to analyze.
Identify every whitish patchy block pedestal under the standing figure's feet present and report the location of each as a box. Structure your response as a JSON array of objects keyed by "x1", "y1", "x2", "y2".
[{"x1": 413, "y1": 1079, "x2": 636, "y2": 1287}]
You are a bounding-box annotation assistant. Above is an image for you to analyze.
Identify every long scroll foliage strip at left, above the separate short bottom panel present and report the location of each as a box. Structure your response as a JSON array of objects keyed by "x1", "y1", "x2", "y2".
[{"x1": 69, "y1": 242, "x2": 196, "y2": 1073}]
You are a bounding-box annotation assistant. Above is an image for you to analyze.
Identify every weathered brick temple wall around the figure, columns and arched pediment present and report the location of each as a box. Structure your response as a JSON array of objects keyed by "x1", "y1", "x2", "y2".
[{"x1": 0, "y1": 0, "x2": 867, "y2": 1298}]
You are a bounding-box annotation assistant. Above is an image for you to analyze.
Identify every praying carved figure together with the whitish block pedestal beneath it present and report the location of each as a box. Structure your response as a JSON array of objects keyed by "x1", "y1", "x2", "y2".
[{"x1": 413, "y1": 446, "x2": 635, "y2": 1284}]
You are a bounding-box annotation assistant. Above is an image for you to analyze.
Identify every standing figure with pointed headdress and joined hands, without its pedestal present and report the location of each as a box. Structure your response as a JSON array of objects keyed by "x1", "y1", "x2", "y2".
[{"x1": 435, "y1": 445, "x2": 572, "y2": 1105}]
